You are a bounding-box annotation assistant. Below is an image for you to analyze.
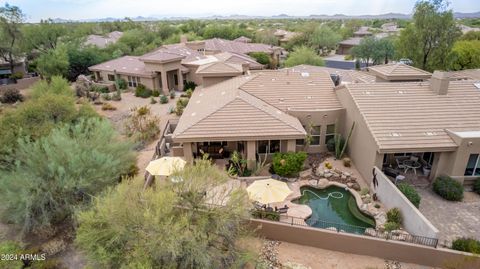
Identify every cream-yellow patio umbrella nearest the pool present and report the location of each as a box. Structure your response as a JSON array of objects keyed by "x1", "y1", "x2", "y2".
[{"x1": 247, "y1": 178, "x2": 292, "y2": 204}]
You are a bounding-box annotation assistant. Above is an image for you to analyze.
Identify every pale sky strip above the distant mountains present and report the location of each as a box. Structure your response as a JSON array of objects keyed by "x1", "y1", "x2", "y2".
[{"x1": 0, "y1": 0, "x2": 480, "y2": 22}]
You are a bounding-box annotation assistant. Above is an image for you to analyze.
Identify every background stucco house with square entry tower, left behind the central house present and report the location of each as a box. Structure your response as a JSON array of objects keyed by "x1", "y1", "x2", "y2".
[{"x1": 89, "y1": 42, "x2": 263, "y2": 94}]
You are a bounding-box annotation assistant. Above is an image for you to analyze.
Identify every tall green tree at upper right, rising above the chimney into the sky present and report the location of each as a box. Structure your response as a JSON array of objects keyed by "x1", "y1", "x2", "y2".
[{"x1": 397, "y1": 0, "x2": 461, "y2": 71}]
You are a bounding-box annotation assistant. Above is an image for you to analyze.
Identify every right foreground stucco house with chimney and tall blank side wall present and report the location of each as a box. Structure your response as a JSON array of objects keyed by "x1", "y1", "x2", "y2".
[{"x1": 336, "y1": 72, "x2": 480, "y2": 185}]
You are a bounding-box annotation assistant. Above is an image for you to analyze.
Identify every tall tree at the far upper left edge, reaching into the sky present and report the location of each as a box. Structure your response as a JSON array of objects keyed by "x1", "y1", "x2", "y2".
[{"x1": 0, "y1": 4, "x2": 25, "y2": 74}]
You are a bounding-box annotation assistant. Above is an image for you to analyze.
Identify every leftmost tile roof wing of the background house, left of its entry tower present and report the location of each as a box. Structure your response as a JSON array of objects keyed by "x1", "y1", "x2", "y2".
[{"x1": 88, "y1": 56, "x2": 155, "y2": 77}]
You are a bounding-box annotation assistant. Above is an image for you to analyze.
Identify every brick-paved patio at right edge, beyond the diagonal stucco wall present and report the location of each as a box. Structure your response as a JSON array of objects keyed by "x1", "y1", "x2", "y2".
[{"x1": 417, "y1": 188, "x2": 480, "y2": 246}]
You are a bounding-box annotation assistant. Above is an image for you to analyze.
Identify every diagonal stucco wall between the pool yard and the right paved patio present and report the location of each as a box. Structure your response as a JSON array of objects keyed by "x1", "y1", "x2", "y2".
[{"x1": 374, "y1": 167, "x2": 439, "y2": 238}]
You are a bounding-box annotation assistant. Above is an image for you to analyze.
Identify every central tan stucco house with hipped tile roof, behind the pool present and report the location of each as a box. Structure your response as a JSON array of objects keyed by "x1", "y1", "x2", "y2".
[{"x1": 172, "y1": 69, "x2": 344, "y2": 167}]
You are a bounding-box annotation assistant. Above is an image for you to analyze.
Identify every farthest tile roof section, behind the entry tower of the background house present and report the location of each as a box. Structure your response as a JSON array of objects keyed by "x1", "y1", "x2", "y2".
[{"x1": 205, "y1": 38, "x2": 281, "y2": 54}]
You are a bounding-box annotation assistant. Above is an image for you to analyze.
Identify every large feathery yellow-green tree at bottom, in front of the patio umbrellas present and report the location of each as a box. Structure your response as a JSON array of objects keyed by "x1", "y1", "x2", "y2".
[{"x1": 76, "y1": 160, "x2": 250, "y2": 268}]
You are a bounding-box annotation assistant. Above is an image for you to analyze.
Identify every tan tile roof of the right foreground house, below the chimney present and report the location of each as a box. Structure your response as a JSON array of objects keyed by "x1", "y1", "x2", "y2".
[{"x1": 339, "y1": 81, "x2": 480, "y2": 152}]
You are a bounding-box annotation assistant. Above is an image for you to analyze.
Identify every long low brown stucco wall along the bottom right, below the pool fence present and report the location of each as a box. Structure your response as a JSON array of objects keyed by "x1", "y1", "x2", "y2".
[{"x1": 251, "y1": 219, "x2": 480, "y2": 269}]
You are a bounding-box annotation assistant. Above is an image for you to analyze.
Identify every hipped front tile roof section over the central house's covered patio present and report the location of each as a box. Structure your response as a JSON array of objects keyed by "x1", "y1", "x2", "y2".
[{"x1": 173, "y1": 75, "x2": 306, "y2": 141}]
